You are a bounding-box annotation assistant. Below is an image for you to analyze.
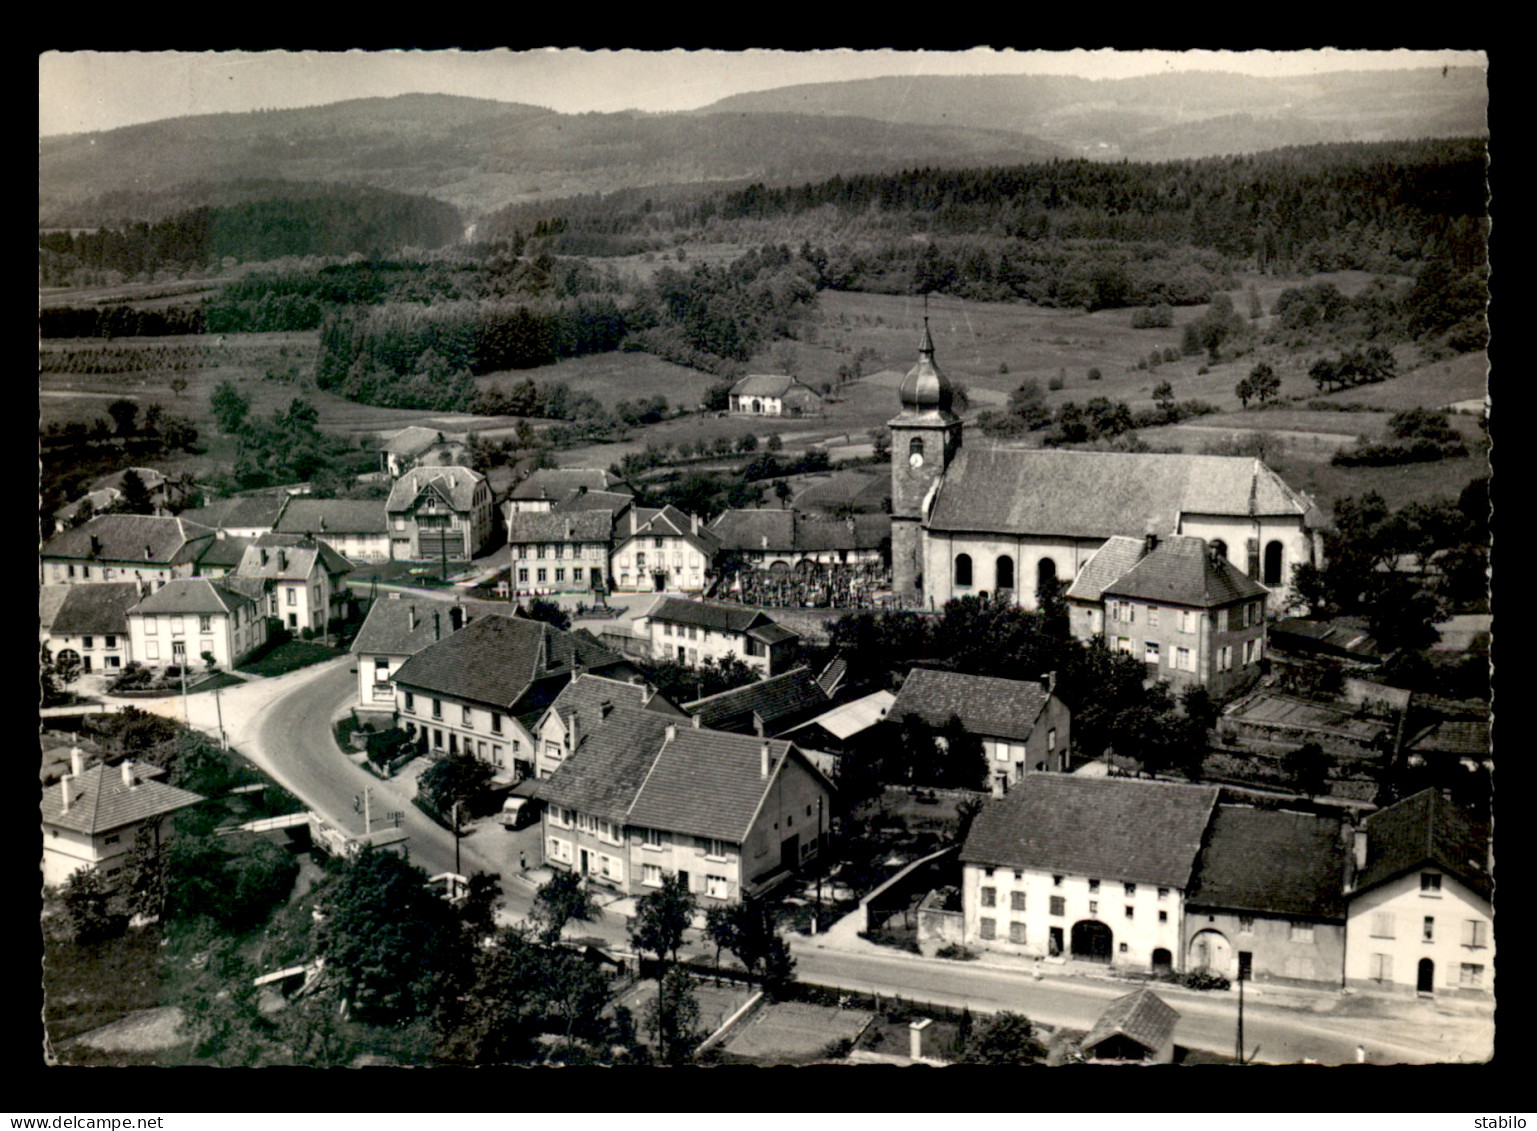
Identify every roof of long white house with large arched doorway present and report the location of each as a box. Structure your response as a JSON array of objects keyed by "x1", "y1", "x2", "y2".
[{"x1": 961, "y1": 771, "x2": 1220, "y2": 890}]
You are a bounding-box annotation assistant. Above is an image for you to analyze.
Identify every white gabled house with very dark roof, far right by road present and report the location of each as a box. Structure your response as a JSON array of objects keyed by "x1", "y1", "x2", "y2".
[{"x1": 1345, "y1": 790, "x2": 1494, "y2": 996}]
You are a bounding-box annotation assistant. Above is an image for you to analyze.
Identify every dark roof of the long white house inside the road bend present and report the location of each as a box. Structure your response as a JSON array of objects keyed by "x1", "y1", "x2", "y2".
[{"x1": 395, "y1": 613, "x2": 624, "y2": 710}]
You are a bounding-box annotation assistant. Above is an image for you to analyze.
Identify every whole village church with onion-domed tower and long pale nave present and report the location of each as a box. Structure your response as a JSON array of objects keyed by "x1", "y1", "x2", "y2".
[{"x1": 890, "y1": 320, "x2": 1323, "y2": 610}]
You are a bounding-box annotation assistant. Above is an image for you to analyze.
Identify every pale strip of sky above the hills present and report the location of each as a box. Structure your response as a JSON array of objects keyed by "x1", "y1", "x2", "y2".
[{"x1": 38, "y1": 48, "x2": 1488, "y2": 137}]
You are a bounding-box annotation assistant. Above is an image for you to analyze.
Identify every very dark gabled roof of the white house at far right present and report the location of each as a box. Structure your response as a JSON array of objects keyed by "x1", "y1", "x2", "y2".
[{"x1": 1354, "y1": 790, "x2": 1491, "y2": 899}]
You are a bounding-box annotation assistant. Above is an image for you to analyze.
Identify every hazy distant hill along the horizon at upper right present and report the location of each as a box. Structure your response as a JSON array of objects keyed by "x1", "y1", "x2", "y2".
[{"x1": 701, "y1": 68, "x2": 1488, "y2": 160}]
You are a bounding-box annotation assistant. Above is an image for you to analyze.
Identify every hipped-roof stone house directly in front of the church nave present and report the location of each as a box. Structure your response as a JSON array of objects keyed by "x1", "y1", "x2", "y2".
[{"x1": 1067, "y1": 535, "x2": 1268, "y2": 698}]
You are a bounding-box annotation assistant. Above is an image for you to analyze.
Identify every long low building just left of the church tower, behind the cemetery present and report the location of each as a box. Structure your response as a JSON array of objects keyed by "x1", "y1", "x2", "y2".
[{"x1": 709, "y1": 507, "x2": 891, "y2": 570}]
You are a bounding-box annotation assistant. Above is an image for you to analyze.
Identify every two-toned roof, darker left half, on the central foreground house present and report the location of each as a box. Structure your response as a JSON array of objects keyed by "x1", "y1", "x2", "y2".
[{"x1": 532, "y1": 707, "x2": 825, "y2": 844}]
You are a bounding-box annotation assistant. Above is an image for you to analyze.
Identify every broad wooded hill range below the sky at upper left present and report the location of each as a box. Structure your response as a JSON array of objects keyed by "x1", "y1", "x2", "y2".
[{"x1": 38, "y1": 95, "x2": 1062, "y2": 227}]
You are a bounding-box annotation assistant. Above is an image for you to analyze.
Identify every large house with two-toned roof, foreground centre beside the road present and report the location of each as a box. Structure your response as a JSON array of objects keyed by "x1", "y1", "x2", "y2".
[{"x1": 532, "y1": 705, "x2": 833, "y2": 908}]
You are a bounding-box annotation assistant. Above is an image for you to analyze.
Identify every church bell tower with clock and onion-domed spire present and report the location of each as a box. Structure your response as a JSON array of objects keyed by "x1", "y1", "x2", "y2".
[{"x1": 890, "y1": 318, "x2": 961, "y2": 596}]
